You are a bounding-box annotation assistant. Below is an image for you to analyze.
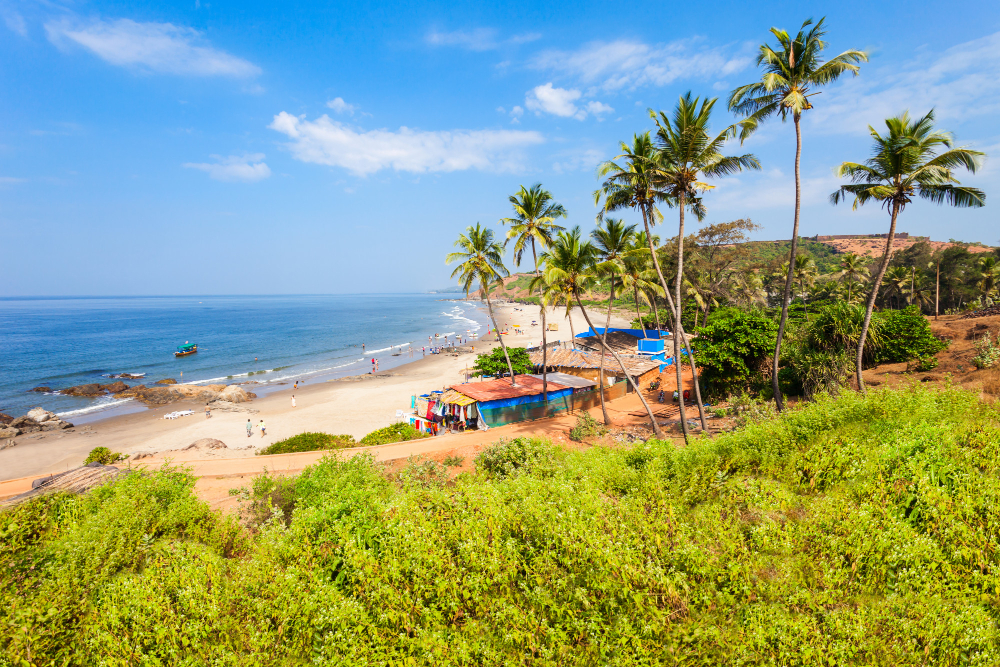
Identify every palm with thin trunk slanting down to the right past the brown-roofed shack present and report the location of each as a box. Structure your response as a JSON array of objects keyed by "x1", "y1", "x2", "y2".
[{"x1": 532, "y1": 227, "x2": 663, "y2": 439}]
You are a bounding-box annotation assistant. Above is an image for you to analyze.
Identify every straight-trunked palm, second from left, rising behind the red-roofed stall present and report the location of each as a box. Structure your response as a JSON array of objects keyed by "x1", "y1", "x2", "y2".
[{"x1": 500, "y1": 183, "x2": 566, "y2": 401}]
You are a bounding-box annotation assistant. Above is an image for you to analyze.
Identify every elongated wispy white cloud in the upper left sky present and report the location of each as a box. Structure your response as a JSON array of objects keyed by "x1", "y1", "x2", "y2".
[{"x1": 45, "y1": 19, "x2": 260, "y2": 77}]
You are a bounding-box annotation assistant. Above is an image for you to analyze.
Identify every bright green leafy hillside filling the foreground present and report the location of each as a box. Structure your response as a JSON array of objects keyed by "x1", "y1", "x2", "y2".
[{"x1": 0, "y1": 388, "x2": 1000, "y2": 665}]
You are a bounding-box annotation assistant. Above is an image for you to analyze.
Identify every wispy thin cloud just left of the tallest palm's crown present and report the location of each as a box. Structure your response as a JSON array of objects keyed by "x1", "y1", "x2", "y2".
[{"x1": 531, "y1": 39, "x2": 752, "y2": 91}]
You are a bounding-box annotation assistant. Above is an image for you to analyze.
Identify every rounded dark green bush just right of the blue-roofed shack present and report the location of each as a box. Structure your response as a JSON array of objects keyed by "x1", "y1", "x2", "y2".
[{"x1": 692, "y1": 308, "x2": 778, "y2": 398}]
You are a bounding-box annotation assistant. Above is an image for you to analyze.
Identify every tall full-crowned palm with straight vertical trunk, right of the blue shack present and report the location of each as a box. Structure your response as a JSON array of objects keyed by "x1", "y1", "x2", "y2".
[{"x1": 649, "y1": 92, "x2": 760, "y2": 440}]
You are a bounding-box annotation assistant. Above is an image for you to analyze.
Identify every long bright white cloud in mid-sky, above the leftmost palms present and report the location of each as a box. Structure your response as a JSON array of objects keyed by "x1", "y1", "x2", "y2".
[{"x1": 268, "y1": 111, "x2": 544, "y2": 176}]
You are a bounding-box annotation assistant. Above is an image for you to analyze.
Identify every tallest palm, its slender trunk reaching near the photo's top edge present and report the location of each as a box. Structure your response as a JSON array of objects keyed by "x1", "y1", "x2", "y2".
[{"x1": 729, "y1": 18, "x2": 868, "y2": 410}]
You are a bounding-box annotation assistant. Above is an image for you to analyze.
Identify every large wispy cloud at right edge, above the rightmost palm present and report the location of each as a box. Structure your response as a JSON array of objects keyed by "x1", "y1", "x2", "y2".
[{"x1": 805, "y1": 32, "x2": 1000, "y2": 136}]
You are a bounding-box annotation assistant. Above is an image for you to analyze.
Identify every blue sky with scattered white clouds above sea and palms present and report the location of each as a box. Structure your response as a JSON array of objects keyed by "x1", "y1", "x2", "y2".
[{"x1": 0, "y1": 0, "x2": 1000, "y2": 296}]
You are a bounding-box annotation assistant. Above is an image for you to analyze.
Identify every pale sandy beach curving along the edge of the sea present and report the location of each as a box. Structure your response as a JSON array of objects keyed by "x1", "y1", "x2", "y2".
[{"x1": 0, "y1": 304, "x2": 627, "y2": 481}]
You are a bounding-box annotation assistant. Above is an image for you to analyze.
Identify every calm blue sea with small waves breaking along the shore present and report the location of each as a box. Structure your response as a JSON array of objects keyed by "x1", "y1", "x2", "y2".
[{"x1": 0, "y1": 294, "x2": 488, "y2": 421}]
